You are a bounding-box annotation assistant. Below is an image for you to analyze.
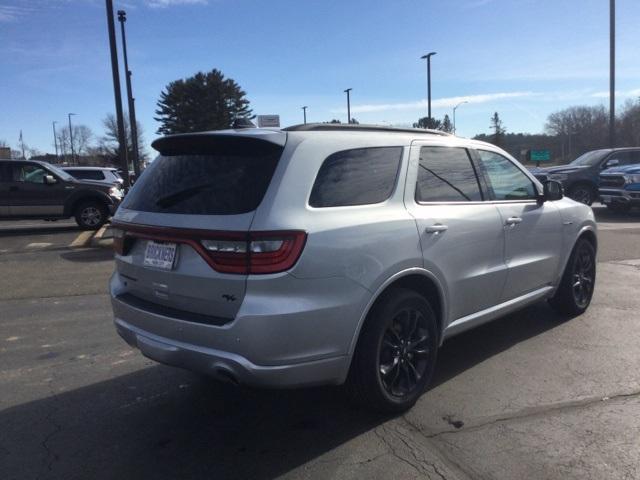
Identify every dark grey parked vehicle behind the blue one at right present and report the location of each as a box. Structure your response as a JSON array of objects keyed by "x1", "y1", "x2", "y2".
[{"x1": 534, "y1": 147, "x2": 640, "y2": 205}]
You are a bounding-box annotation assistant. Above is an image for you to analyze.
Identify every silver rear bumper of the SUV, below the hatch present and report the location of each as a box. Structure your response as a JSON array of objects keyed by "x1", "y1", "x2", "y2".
[{"x1": 110, "y1": 272, "x2": 370, "y2": 387}]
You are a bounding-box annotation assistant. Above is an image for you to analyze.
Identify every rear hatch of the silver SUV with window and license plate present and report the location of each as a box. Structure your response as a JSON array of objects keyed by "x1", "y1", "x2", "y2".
[{"x1": 114, "y1": 132, "x2": 286, "y2": 324}]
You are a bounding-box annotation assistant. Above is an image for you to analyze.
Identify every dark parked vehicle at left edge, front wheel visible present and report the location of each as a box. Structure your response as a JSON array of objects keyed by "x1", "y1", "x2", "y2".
[{"x1": 0, "y1": 160, "x2": 122, "y2": 230}]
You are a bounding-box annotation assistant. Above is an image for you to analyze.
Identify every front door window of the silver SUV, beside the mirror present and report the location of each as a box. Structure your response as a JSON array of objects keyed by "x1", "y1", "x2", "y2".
[{"x1": 478, "y1": 150, "x2": 537, "y2": 200}]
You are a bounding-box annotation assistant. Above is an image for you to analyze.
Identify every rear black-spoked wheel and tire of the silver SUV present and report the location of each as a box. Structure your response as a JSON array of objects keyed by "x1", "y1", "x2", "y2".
[{"x1": 346, "y1": 288, "x2": 438, "y2": 413}]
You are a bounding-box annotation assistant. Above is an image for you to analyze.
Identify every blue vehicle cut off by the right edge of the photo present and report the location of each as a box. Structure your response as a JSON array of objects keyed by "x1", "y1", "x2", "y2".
[{"x1": 599, "y1": 163, "x2": 640, "y2": 212}]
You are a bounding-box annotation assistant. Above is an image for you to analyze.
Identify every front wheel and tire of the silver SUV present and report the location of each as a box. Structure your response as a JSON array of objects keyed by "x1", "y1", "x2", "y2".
[{"x1": 549, "y1": 239, "x2": 596, "y2": 316}]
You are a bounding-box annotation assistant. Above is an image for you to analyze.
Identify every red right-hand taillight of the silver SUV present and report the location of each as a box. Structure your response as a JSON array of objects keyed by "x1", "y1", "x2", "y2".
[{"x1": 201, "y1": 231, "x2": 307, "y2": 274}]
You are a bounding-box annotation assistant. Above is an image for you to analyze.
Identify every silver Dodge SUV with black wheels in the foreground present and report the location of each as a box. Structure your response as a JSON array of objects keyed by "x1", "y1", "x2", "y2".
[{"x1": 110, "y1": 125, "x2": 597, "y2": 411}]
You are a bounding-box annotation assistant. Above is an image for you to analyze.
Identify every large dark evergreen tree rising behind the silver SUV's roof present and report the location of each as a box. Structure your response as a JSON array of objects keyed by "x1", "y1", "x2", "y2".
[{"x1": 154, "y1": 69, "x2": 253, "y2": 135}]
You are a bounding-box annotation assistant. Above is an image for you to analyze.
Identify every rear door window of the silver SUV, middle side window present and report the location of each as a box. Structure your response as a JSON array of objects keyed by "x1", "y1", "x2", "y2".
[{"x1": 416, "y1": 147, "x2": 482, "y2": 202}]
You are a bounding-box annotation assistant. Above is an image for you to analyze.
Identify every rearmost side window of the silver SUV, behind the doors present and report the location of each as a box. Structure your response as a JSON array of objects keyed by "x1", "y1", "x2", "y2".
[{"x1": 309, "y1": 147, "x2": 402, "y2": 207}]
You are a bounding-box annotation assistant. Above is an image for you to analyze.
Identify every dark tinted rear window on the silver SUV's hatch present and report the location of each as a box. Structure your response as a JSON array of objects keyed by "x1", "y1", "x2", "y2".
[{"x1": 122, "y1": 137, "x2": 283, "y2": 215}]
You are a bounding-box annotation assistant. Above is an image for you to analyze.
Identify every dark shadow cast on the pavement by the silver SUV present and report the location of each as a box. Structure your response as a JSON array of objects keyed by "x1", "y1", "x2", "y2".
[{"x1": 0, "y1": 305, "x2": 558, "y2": 480}]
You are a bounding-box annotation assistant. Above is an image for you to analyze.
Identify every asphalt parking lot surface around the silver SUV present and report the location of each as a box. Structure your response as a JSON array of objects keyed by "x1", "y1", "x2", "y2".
[{"x1": 0, "y1": 206, "x2": 640, "y2": 480}]
